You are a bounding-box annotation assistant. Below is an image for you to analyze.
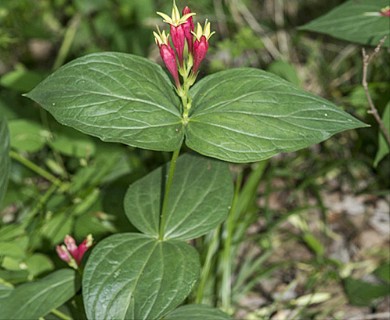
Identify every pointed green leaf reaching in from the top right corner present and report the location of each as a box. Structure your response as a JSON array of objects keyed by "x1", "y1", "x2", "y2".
[{"x1": 300, "y1": 0, "x2": 390, "y2": 47}]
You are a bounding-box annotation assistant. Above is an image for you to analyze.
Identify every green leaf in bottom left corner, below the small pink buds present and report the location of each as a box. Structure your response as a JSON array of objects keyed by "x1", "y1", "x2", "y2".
[{"x1": 0, "y1": 269, "x2": 79, "y2": 320}]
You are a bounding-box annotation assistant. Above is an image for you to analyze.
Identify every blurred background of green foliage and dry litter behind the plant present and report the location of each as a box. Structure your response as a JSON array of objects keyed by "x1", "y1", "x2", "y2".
[{"x1": 0, "y1": 0, "x2": 390, "y2": 319}]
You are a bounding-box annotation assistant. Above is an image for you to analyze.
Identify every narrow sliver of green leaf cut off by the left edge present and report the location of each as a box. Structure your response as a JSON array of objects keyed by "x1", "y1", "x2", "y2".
[{"x1": 0, "y1": 116, "x2": 10, "y2": 207}]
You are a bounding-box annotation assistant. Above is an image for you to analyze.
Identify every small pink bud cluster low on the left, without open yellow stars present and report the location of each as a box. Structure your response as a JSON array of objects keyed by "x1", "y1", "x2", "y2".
[{"x1": 56, "y1": 234, "x2": 93, "y2": 269}]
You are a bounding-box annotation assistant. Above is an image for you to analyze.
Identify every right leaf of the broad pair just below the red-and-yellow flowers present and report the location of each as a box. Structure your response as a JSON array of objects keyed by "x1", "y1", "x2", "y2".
[{"x1": 186, "y1": 68, "x2": 365, "y2": 162}]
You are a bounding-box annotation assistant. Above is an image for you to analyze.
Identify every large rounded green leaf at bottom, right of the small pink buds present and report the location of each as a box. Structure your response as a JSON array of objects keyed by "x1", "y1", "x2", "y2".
[{"x1": 83, "y1": 233, "x2": 200, "y2": 320}]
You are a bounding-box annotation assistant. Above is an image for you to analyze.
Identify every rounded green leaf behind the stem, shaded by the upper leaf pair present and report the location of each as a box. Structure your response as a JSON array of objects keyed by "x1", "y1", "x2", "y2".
[{"x1": 124, "y1": 154, "x2": 233, "y2": 240}]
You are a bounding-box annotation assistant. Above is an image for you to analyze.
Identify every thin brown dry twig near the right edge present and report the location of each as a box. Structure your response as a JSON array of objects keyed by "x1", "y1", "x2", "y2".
[{"x1": 362, "y1": 37, "x2": 390, "y2": 147}]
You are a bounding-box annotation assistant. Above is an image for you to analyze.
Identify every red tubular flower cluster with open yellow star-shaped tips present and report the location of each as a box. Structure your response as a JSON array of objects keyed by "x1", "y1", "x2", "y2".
[{"x1": 153, "y1": 0, "x2": 214, "y2": 89}]
